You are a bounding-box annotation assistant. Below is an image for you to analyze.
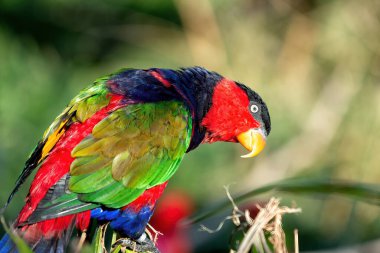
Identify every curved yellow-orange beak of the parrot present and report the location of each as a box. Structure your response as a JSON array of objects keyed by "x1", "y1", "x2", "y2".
[{"x1": 237, "y1": 128, "x2": 266, "y2": 158}]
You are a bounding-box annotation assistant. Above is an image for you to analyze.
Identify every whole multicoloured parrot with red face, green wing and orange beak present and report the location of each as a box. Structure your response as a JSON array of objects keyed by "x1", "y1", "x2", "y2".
[{"x1": 0, "y1": 67, "x2": 271, "y2": 253}]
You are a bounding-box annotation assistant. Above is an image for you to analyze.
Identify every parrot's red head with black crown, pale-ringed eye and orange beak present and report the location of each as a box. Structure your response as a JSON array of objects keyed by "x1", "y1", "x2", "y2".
[{"x1": 201, "y1": 78, "x2": 271, "y2": 158}]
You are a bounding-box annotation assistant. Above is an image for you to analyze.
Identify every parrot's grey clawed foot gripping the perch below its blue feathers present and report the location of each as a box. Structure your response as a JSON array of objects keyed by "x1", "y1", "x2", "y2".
[{"x1": 112, "y1": 233, "x2": 160, "y2": 253}]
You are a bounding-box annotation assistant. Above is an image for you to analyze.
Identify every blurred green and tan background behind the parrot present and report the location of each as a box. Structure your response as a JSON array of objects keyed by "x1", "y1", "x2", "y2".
[{"x1": 0, "y1": 0, "x2": 380, "y2": 252}]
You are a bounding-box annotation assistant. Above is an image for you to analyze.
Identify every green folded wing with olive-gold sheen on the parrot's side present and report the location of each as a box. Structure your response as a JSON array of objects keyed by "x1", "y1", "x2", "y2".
[{"x1": 69, "y1": 101, "x2": 191, "y2": 208}]
